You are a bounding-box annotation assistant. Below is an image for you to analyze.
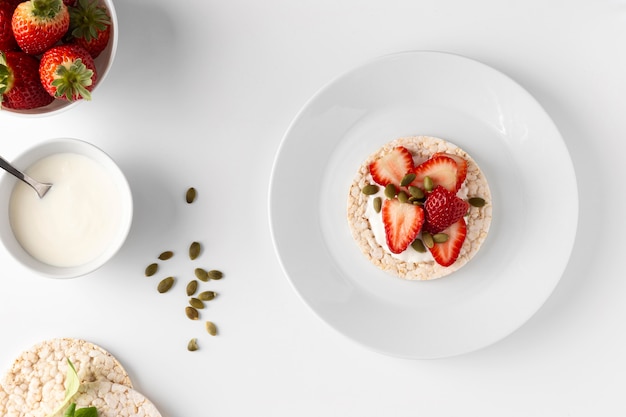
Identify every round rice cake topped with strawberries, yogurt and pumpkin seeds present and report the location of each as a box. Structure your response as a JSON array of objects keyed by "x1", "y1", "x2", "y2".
[{"x1": 348, "y1": 136, "x2": 492, "y2": 280}]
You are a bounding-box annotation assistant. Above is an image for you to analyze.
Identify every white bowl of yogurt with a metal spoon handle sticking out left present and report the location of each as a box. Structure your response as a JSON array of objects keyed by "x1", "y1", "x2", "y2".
[{"x1": 0, "y1": 138, "x2": 133, "y2": 278}]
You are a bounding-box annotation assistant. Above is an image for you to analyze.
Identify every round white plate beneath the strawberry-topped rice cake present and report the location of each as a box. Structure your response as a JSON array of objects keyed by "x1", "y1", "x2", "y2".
[{"x1": 269, "y1": 52, "x2": 578, "y2": 359}]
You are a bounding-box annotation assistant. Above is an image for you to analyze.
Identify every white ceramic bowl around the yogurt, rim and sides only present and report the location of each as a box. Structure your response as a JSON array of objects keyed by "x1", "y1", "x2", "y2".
[{"x1": 0, "y1": 138, "x2": 133, "y2": 278}]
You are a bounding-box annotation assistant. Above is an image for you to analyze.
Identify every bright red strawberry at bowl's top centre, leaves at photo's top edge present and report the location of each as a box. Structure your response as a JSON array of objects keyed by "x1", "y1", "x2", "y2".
[{"x1": 11, "y1": 0, "x2": 70, "y2": 55}]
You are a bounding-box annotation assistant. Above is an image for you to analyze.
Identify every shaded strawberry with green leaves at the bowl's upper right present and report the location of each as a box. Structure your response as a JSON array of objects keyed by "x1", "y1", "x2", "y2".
[{"x1": 69, "y1": 0, "x2": 111, "y2": 58}]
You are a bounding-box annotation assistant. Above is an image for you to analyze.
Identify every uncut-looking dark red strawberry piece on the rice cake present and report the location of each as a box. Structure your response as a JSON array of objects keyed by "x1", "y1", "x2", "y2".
[{"x1": 424, "y1": 185, "x2": 469, "y2": 233}]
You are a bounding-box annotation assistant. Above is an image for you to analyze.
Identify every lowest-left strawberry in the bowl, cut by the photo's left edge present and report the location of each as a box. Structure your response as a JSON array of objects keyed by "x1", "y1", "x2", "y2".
[{"x1": 0, "y1": 51, "x2": 54, "y2": 110}]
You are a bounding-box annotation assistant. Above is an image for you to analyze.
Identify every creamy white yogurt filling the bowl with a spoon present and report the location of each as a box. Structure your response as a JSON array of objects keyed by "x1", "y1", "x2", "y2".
[{"x1": 9, "y1": 153, "x2": 122, "y2": 267}]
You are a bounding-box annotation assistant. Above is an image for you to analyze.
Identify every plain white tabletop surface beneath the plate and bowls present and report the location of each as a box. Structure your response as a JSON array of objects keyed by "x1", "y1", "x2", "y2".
[{"x1": 0, "y1": 0, "x2": 626, "y2": 417}]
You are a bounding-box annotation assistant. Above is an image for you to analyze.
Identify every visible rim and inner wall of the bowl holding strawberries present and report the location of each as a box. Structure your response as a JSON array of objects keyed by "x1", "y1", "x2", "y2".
[{"x1": 1, "y1": 0, "x2": 119, "y2": 117}]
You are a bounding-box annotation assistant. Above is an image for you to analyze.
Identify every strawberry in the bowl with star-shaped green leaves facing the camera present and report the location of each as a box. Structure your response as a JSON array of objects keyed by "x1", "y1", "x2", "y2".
[{"x1": 39, "y1": 45, "x2": 98, "y2": 101}]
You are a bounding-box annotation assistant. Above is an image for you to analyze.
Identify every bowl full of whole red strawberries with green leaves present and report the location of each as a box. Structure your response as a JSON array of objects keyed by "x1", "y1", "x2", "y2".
[{"x1": 0, "y1": 0, "x2": 117, "y2": 116}]
